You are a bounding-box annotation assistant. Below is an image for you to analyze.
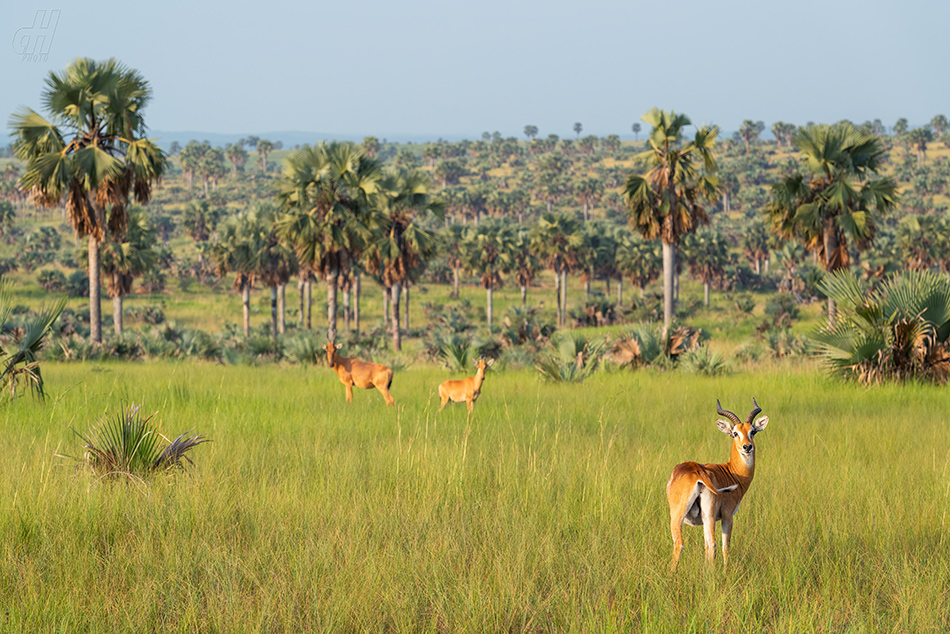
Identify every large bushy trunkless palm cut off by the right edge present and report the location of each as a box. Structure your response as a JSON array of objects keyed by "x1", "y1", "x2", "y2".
[{"x1": 814, "y1": 271, "x2": 950, "y2": 384}]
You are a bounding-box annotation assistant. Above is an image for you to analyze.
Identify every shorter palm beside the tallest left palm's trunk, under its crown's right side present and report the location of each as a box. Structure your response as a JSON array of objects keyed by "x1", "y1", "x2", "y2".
[{"x1": 97, "y1": 205, "x2": 158, "y2": 335}]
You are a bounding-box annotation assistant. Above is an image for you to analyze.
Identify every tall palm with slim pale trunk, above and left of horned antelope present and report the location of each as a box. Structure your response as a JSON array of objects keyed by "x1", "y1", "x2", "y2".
[{"x1": 624, "y1": 108, "x2": 719, "y2": 329}]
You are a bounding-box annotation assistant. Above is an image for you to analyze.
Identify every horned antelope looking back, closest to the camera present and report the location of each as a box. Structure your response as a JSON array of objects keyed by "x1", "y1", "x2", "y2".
[{"x1": 666, "y1": 399, "x2": 769, "y2": 570}]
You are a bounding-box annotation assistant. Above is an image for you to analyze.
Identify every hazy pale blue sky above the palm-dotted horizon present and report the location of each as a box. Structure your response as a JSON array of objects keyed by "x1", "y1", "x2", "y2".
[{"x1": 0, "y1": 0, "x2": 950, "y2": 139}]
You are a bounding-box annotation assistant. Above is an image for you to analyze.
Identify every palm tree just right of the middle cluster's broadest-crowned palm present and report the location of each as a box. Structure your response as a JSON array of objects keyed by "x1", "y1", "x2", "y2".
[{"x1": 367, "y1": 167, "x2": 445, "y2": 351}]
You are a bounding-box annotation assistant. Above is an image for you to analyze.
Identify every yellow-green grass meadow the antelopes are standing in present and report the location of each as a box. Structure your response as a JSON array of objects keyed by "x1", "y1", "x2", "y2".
[{"x1": 0, "y1": 363, "x2": 950, "y2": 632}]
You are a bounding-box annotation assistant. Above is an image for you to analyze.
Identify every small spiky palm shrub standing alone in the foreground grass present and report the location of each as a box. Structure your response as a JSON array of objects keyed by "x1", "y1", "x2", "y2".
[{"x1": 73, "y1": 404, "x2": 209, "y2": 477}]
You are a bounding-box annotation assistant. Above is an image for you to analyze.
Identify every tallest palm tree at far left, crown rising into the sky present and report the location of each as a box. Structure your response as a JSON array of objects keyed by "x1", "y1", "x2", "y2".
[{"x1": 9, "y1": 58, "x2": 166, "y2": 344}]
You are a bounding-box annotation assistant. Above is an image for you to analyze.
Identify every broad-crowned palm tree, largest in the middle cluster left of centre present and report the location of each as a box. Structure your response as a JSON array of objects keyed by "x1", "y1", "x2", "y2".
[{"x1": 277, "y1": 142, "x2": 380, "y2": 341}]
